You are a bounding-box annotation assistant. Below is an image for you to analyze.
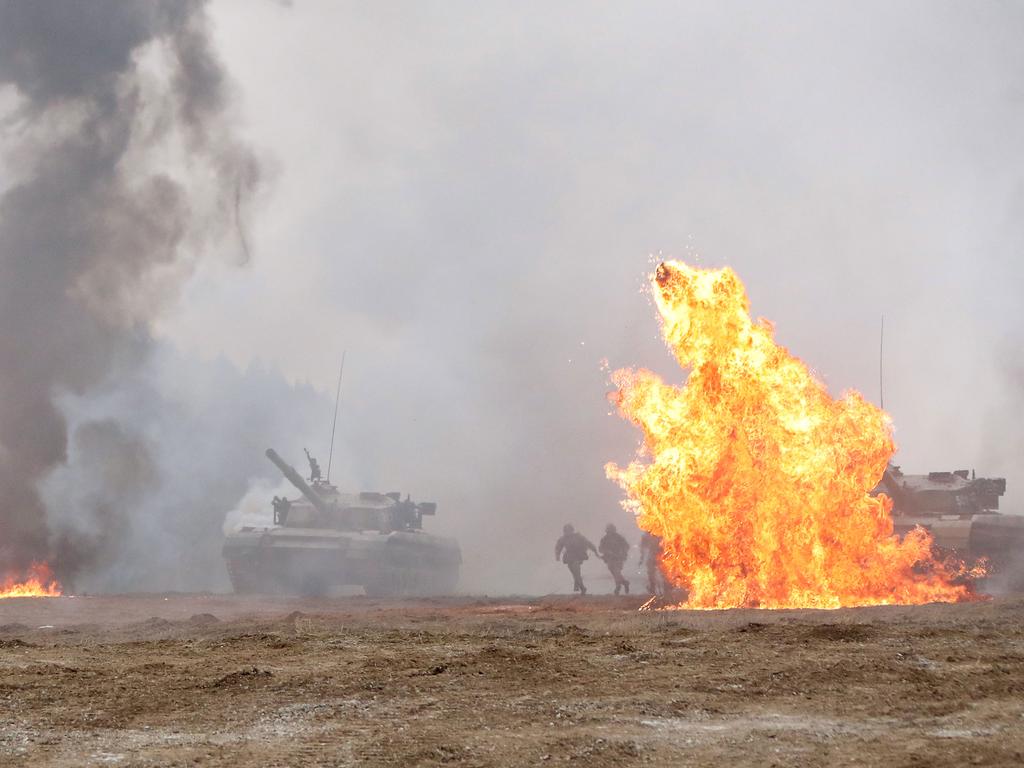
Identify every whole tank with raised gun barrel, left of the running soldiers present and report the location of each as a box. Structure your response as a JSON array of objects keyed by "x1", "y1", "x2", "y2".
[{"x1": 223, "y1": 449, "x2": 462, "y2": 596}]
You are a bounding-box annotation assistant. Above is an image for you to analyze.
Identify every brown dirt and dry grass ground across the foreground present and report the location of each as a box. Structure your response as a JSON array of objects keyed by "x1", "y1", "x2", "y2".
[{"x1": 0, "y1": 595, "x2": 1024, "y2": 768}]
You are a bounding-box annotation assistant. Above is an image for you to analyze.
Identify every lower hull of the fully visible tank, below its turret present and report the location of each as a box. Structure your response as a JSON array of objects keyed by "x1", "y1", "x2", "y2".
[{"x1": 223, "y1": 526, "x2": 462, "y2": 596}]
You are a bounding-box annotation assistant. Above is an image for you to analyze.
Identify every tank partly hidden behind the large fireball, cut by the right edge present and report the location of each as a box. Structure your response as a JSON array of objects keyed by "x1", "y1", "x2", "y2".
[{"x1": 874, "y1": 465, "x2": 1024, "y2": 591}]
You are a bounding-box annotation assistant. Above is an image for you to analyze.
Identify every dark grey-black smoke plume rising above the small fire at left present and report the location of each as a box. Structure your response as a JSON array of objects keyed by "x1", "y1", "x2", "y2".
[{"x1": 0, "y1": 0, "x2": 259, "y2": 580}]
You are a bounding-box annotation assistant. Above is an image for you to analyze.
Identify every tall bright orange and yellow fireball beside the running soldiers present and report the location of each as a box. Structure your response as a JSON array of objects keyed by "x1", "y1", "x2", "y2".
[{"x1": 605, "y1": 261, "x2": 973, "y2": 608}]
